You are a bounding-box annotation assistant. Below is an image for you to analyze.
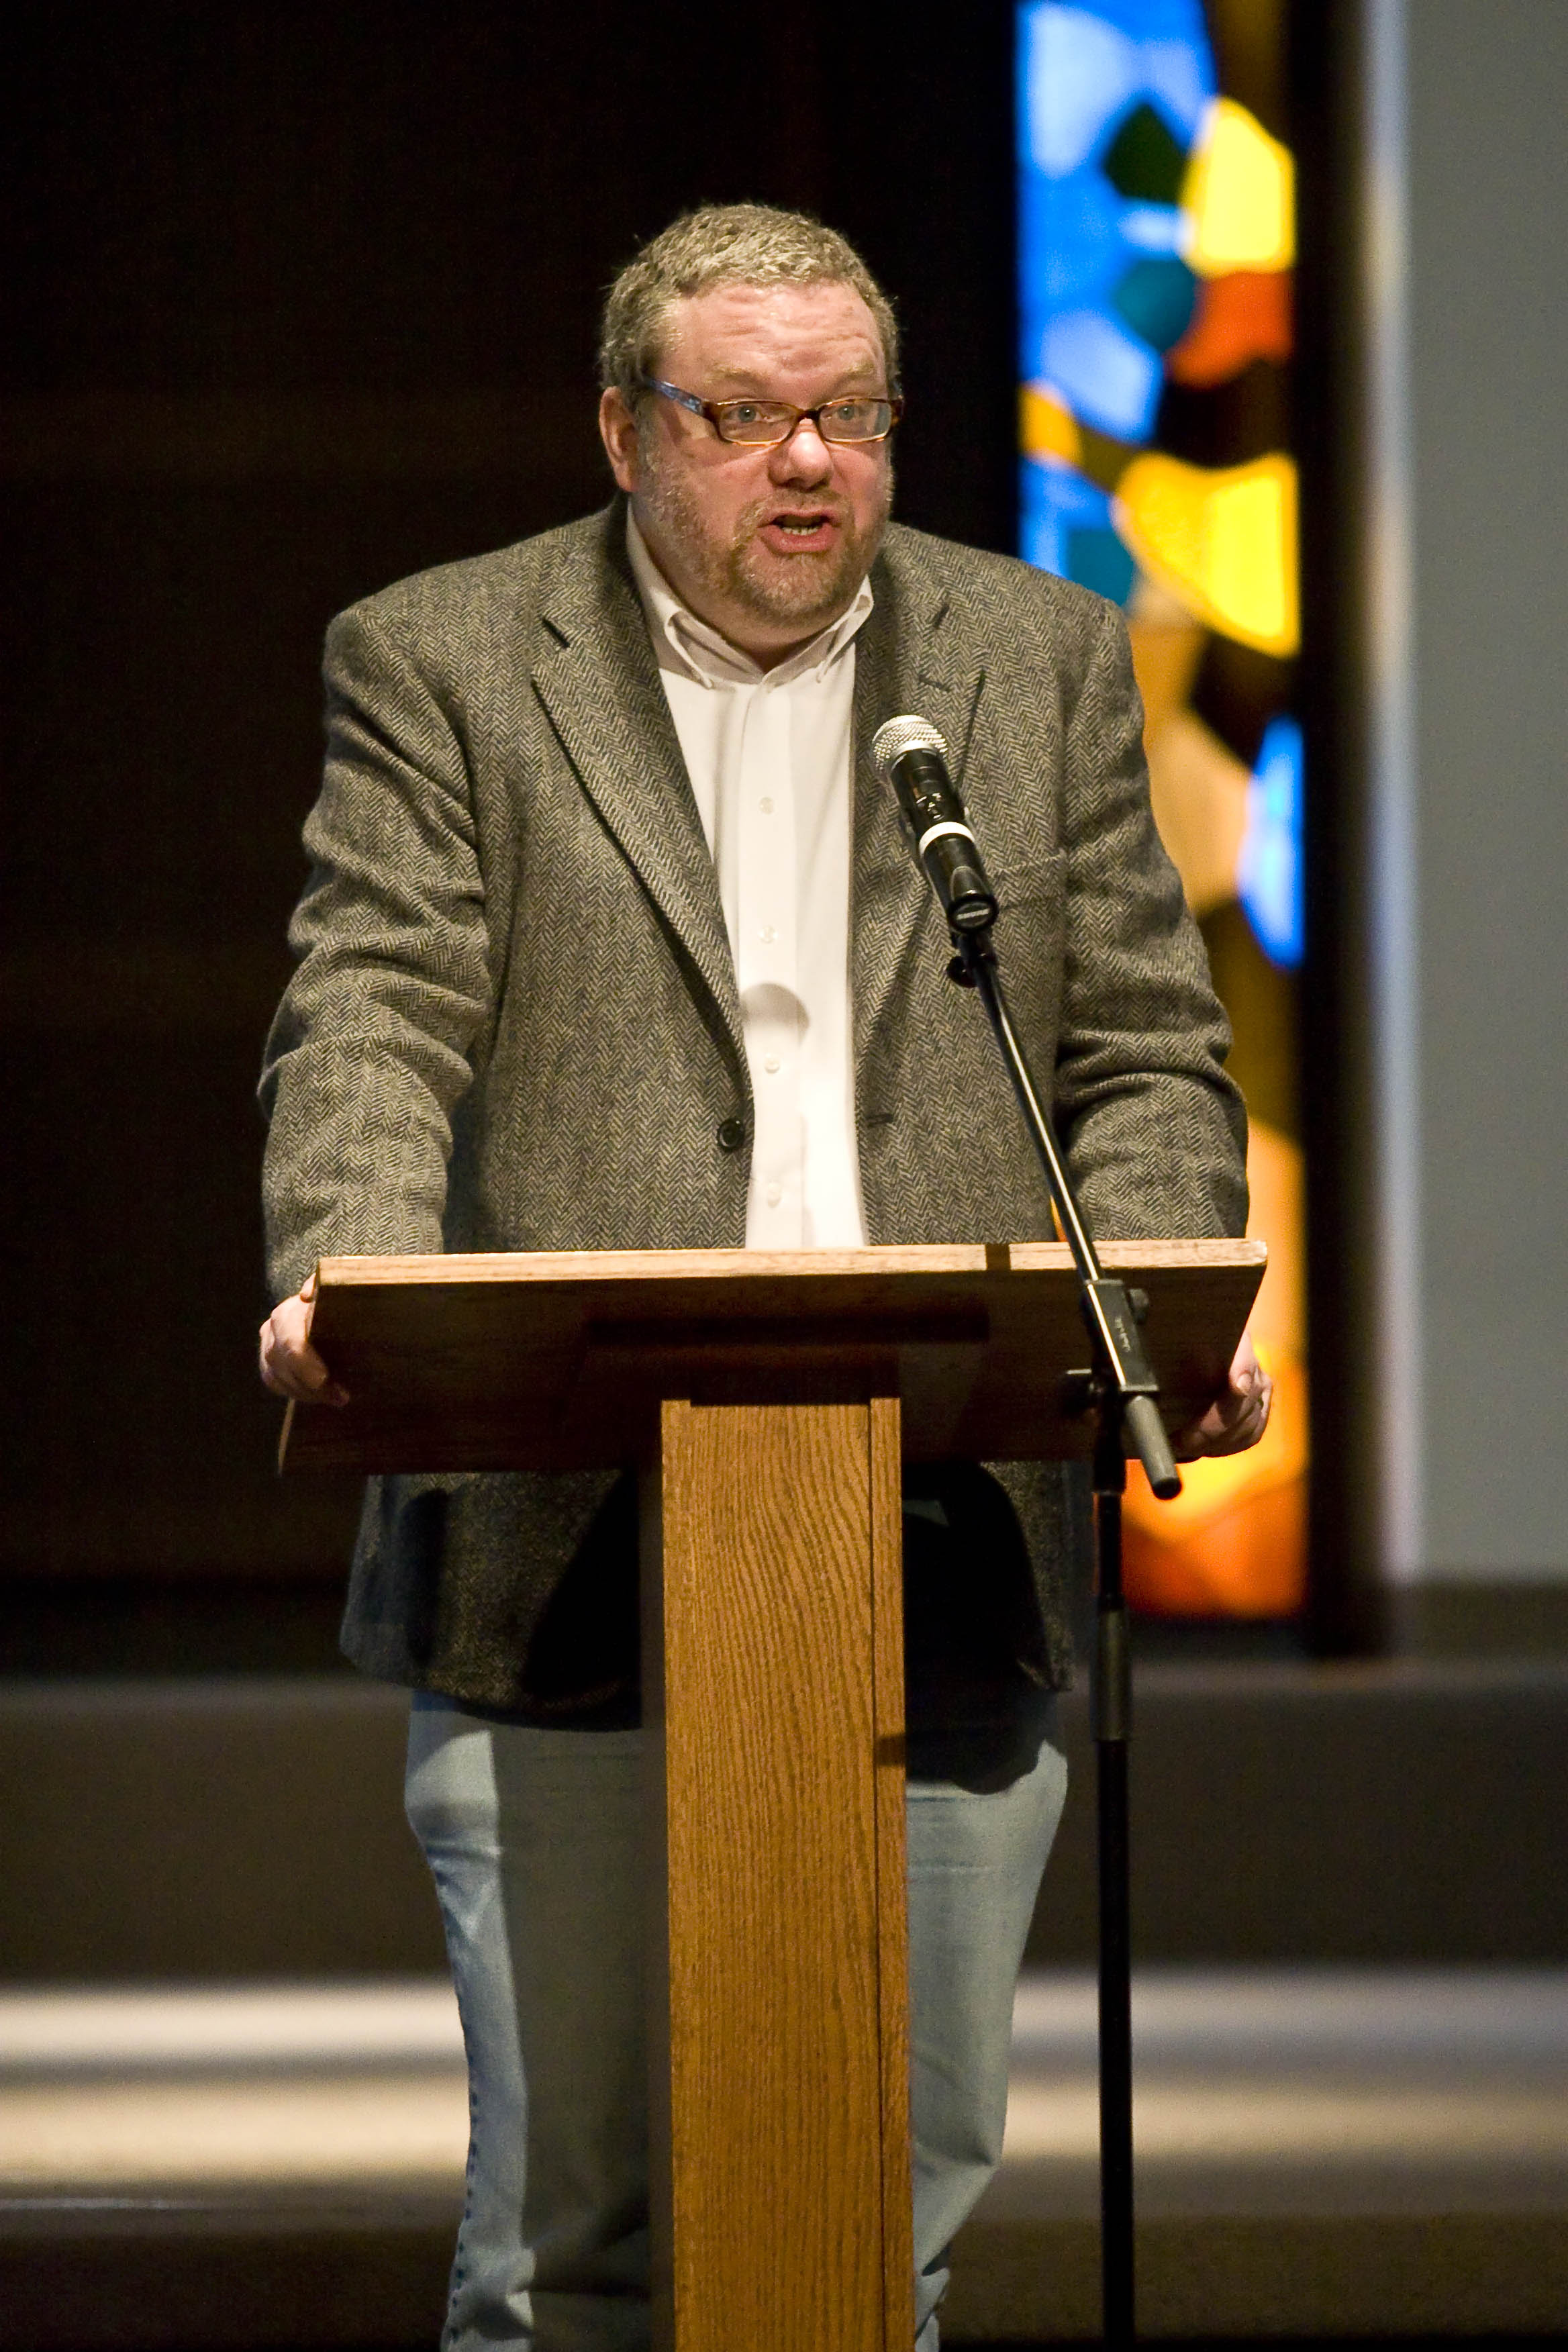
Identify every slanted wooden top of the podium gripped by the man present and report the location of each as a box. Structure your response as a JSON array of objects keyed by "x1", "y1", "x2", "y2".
[{"x1": 280, "y1": 1242, "x2": 1265, "y2": 1470}]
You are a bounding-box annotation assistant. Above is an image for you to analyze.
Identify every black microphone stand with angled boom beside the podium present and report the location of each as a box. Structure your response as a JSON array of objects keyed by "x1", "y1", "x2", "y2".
[{"x1": 947, "y1": 910, "x2": 1180, "y2": 2345}]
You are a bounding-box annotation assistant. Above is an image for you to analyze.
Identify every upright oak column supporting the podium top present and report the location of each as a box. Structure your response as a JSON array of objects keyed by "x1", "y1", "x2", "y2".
[{"x1": 646, "y1": 1402, "x2": 912, "y2": 2352}]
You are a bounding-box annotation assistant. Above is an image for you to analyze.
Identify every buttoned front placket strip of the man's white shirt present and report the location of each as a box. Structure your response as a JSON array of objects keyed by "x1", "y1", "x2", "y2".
[{"x1": 736, "y1": 685, "x2": 801, "y2": 1249}]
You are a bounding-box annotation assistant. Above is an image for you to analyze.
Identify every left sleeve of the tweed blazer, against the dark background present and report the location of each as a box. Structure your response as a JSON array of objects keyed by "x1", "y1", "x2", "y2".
[{"x1": 261, "y1": 607, "x2": 491, "y2": 1296}]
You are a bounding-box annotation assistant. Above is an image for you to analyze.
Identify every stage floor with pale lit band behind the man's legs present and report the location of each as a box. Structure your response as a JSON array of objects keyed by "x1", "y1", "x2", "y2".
[{"x1": 0, "y1": 1969, "x2": 1568, "y2": 2352}]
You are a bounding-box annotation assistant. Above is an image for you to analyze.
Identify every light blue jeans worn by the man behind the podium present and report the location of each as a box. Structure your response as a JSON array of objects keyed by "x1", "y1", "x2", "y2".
[{"x1": 407, "y1": 1694, "x2": 1067, "y2": 2352}]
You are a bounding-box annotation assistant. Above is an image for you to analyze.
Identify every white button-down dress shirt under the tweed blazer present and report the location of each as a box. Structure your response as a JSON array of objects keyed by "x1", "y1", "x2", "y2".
[{"x1": 626, "y1": 508, "x2": 872, "y2": 1249}]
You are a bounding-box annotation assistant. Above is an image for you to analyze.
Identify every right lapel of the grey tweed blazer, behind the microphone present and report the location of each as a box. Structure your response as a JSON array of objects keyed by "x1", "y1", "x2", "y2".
[{"x1": 851, "y1": 541, "x2": 985, "y2": 1091}]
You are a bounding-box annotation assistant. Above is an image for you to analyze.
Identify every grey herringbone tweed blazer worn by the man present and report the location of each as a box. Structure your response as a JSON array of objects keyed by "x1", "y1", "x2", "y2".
[{"x1": 261, "y1": 501, "x2": 1246, "y2": 1712}]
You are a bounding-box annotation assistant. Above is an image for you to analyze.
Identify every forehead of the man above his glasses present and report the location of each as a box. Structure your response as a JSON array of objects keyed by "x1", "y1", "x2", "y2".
[{"x1": 658, "y1": 285, "x2": 884, "y2": 397}]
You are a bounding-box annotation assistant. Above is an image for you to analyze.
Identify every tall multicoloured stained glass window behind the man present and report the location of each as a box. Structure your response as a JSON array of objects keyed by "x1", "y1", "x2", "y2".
[{"x1": 1018, "y1": 0, "x2": 1310, "y2": 1616}]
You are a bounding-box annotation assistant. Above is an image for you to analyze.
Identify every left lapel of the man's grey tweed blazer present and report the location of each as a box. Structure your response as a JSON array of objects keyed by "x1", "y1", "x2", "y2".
[{"x1": 534, "y1": 503, "x2": 745, "y2": 1073}]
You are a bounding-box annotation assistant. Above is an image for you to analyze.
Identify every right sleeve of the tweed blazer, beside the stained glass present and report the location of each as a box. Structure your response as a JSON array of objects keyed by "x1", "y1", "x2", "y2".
[{"x1": 1056, "y1": 609, "x2": 1246, "y2": 1240}]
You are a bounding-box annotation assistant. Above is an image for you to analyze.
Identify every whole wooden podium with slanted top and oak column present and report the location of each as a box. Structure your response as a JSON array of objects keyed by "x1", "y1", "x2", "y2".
[{"x1": 282, "y1": 1242, "x2": 1265, "y2": 2352}]
